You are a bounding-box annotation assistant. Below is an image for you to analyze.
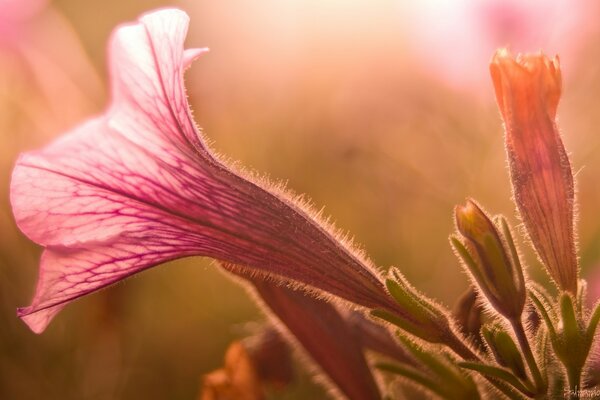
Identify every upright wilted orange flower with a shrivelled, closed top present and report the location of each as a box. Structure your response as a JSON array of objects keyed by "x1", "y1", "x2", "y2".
[{"x1": 490, "y1": 49, "x2": 578, "y2": 293}]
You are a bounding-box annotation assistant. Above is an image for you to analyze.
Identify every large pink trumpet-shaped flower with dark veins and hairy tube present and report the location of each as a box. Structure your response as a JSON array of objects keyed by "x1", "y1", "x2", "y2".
[{"x1": 11, "y1": 9, "x2": 394, "y2": 333}]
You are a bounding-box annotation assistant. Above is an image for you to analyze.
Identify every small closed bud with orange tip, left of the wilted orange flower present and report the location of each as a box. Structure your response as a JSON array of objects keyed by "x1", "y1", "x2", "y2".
[{"x1": 450, "y1": 200, "x2": 526, "y2": 320}]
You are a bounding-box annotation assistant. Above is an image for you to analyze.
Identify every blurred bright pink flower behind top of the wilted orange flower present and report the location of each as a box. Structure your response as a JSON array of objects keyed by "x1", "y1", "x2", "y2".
[{"x1": 401, "y1": 0, "x2": 595, "y2": 93}]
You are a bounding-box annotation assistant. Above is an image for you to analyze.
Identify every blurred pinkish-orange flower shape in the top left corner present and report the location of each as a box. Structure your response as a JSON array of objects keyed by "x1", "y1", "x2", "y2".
[{"x1": 0, "y1": 0, "x2": 103, "y2": 138}]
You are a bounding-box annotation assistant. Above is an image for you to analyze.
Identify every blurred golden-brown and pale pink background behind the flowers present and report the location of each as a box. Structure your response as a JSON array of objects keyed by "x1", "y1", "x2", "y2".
[{"x1": 0, "y1": 0, "x2": 600, "y2": 400}]
